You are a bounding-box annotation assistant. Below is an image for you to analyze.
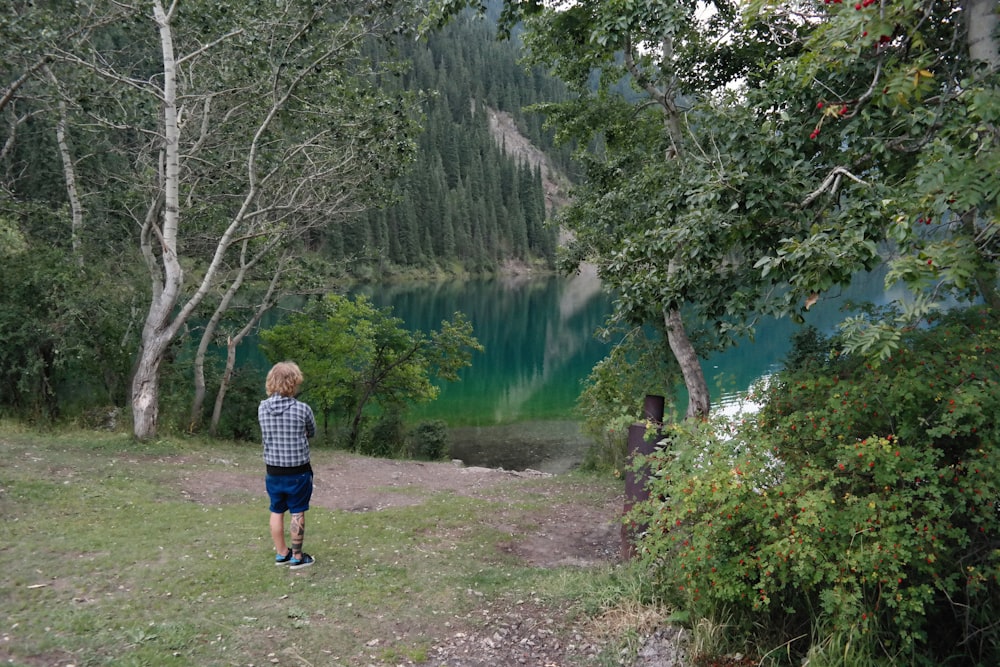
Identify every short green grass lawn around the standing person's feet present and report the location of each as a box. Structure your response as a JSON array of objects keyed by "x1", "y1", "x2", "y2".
[{"x1": 0, "y1": 424, "x2": 621, "y2": 666}]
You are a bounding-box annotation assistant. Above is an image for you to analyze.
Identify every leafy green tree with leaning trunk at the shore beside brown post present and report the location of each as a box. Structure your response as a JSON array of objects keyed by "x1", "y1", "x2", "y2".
[{"x1": 424, "y1": 0, "x2": 812, "y2": 417}]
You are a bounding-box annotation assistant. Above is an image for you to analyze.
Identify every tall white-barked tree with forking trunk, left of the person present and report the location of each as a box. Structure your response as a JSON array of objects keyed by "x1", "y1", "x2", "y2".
[{"x1": 43, "y1": 0, "x2": 409, "y2": 439}]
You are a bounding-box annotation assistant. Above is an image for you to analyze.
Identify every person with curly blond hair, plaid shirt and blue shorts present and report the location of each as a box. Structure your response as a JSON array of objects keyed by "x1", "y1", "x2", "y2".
[{"x1": 257, "y1": 361, "x2": 316, "y2": 570}]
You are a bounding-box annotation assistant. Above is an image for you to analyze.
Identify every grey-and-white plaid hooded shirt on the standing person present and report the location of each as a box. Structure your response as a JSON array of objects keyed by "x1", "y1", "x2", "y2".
[{"x1": 257, "y1": 394, "x2": 316, "y2": 468}]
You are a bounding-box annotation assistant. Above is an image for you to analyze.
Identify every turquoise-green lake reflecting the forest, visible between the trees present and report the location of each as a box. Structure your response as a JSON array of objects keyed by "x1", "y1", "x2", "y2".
[{"x1": 348, "y1": 271, "x2": 895, "y2": 472}]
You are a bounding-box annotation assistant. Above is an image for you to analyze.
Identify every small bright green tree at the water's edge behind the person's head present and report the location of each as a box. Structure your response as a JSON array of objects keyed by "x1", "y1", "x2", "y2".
[{"x1": 261, "y1": 295, "x2": 483, "y2": 449}]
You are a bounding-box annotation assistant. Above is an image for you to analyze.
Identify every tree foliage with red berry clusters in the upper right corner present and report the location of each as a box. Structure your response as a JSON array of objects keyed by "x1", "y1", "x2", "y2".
[{"x1": 751, "y1": 0, "x2": 1000, "y2": 357}]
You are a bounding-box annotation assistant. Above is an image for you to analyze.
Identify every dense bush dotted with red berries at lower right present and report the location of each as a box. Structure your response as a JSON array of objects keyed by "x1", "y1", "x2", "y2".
[{"x1": 632, "y1": 308, "x2": 1000, "y2": 665}]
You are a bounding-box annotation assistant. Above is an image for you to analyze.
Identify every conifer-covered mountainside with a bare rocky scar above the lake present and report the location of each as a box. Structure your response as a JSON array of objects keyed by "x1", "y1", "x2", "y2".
[{"x1": 324, "y1": 5, "x2": 571, "y2": 280}]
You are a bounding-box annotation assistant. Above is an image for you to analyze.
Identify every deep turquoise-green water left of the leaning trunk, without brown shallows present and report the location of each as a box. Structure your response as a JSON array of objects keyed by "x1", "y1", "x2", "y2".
[{"x1": 354, "y1": 276, "x2": 611, "y2": 426}]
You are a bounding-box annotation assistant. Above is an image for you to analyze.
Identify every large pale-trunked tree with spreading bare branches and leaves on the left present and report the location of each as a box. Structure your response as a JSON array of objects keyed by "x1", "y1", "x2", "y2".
[{"x1": 3, "y1": 0, "x2": 424, "y2": 438}]
